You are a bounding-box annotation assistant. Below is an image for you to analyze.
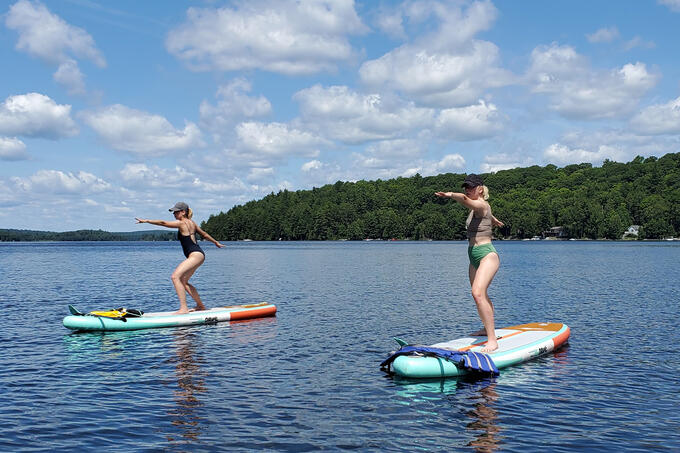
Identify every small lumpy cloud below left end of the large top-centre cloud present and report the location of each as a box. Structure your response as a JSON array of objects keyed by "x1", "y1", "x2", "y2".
[{"x1": 200, "y1": 79, "x2": 272, "y2": 133}]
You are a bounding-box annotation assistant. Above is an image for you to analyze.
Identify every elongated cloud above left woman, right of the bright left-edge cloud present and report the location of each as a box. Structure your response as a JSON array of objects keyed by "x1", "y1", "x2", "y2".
[{"x1": 82, "y1": 104, "x2": 203, "y2": 156}]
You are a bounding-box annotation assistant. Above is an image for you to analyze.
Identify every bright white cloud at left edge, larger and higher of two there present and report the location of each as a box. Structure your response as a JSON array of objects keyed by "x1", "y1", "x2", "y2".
[{"x1": 0, "y1": 93, "x2": 78, "y2": 139}]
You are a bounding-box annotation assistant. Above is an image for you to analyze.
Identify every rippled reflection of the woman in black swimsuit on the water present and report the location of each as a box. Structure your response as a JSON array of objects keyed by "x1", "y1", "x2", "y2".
[{"x1": 168, "y1": 329, "x2": 206, "y2": 443}]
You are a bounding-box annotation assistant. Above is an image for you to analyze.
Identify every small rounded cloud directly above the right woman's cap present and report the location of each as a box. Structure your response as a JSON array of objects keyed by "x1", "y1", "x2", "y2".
[{"x1": 435, "y1": 100, "x2": 503, "y2": 140}]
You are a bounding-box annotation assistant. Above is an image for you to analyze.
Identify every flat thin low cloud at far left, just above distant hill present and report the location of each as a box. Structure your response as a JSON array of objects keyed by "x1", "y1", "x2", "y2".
[{"x1": 12, "y1": 170, "x2": 111, "y2": 194}]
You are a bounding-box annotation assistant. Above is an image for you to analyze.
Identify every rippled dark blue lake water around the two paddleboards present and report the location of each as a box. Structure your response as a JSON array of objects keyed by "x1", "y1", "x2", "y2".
[{"x1": 0, "y1": 238, "x2": 680, "y2": 452}]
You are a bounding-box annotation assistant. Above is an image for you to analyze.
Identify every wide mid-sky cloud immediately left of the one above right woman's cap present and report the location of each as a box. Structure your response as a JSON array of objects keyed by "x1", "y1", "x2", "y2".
[{"x1": 293, "y1": 85, "x2": 434, "y2": 144}]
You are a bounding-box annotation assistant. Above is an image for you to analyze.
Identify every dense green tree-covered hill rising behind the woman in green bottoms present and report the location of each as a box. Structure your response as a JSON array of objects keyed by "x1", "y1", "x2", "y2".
[{"x1": 202, "y1": 153, "x2": 680, "y2": 241}]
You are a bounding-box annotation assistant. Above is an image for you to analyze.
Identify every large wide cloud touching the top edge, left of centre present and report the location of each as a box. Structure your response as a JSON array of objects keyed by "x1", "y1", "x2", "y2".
[{"x1": 166, "y1": 0, "x2": 366, "y2": 75}]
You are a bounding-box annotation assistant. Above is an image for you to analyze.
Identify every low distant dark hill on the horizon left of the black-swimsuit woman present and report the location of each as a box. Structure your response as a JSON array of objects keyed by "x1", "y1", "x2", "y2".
[{"x1": 0, "y1": 229, "x2": 177, "y2": 242}]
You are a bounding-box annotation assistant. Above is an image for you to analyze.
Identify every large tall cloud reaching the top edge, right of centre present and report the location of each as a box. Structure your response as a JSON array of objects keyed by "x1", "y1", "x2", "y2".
[{"x1": 359, "y1": 2, "x2": 512, "y2": 107}]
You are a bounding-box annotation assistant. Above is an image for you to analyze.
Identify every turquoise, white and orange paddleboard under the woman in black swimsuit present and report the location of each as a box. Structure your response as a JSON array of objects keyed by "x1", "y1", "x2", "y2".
[{"x1": 64, "y1": 302, "x2": 276, "y2": 331}]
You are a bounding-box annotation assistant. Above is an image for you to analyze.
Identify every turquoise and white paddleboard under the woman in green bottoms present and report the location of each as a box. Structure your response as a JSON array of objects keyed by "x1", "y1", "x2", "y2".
[{"x1": 391, "y1": 322, "x2": 570, "y2": 378}]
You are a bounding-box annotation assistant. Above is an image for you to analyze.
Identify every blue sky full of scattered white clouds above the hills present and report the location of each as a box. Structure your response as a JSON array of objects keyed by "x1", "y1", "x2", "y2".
[{"x1": 0, "y1": 0, "x2": 680, "y2": 231}]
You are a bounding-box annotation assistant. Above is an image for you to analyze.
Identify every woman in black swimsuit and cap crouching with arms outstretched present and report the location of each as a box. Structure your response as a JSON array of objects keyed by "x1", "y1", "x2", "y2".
[{"x1": 135, "y1": 201, "x2": 224, "y2": 313}]
